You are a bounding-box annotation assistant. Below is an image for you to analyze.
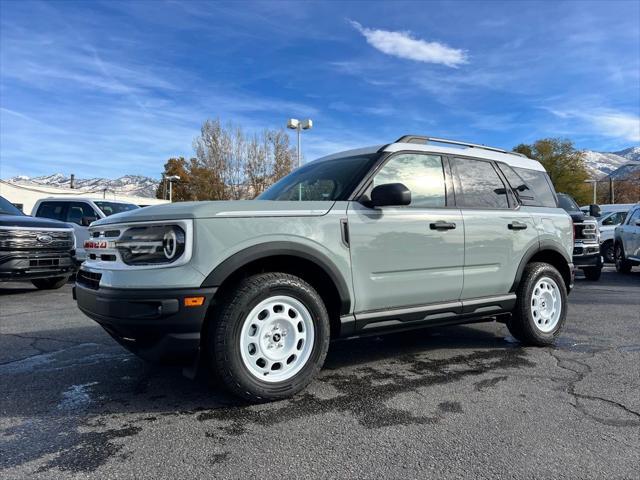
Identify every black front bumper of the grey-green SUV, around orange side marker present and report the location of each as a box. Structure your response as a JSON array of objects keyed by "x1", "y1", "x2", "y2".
[{"x1": 73, "y1": 280, "x2": 216, "y2": 361}]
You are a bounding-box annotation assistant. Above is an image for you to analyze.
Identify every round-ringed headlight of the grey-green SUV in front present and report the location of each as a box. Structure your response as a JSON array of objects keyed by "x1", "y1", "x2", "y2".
[{"x1": 115, "y1": 225, "x2": 186, "y2": 265}]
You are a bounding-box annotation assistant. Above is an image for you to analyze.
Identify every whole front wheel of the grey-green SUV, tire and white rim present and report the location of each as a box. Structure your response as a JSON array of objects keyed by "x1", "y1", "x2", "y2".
[{"x1": 207, "y1": 273, "x2": 330, "y2": 402}]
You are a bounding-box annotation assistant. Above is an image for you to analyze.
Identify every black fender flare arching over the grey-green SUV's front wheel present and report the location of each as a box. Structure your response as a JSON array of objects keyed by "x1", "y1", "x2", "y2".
[{"x1": 201, "y1": 241, "x2": 351, "y2": 314}]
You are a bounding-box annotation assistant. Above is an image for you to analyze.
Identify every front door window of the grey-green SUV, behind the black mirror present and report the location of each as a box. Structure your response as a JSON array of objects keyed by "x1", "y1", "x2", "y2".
[{"x1": 372, "y1": 153, "x2": 446, "y2": 208}]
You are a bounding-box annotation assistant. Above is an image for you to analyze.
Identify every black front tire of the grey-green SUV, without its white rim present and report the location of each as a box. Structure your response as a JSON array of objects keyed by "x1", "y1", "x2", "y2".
[{"x1": 206, "y1": 272, "x2": 330, "y2": 403}]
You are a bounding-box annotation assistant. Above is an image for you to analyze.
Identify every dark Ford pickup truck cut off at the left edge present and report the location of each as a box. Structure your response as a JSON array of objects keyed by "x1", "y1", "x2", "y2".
[{"x1": 0, "y1": 197, "x2": 76, "y2": 289}]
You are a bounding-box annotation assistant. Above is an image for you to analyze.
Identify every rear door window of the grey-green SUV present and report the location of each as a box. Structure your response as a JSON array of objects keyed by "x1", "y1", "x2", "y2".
[{"x1": 451, "y1": 158, "x2": 509, "y2": 208}]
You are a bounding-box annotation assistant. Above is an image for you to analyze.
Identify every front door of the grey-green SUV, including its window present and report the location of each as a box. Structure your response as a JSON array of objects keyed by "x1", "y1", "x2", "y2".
[{"x1": 347, "y1": 153, "x2": 464, "y2": 316}]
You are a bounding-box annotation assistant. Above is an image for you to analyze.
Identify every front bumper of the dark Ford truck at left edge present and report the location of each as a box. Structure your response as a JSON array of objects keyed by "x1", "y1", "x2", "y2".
[{"x1": 0, "y1": 250, "x2": 77, "y2": 281}]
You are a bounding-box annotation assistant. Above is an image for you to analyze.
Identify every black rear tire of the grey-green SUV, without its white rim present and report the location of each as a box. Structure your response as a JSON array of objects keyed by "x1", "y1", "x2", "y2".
[{"x1": 507, "y1": 262, "x2": 567, "y2": 347}]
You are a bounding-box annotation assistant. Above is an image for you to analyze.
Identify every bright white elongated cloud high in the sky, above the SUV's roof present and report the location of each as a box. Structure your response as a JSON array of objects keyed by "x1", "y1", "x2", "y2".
[{"x1": 349, "y1": 20, "x2": 469, "y2": 68}]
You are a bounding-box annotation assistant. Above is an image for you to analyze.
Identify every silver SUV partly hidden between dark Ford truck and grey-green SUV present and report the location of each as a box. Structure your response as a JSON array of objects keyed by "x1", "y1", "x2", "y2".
[{"x1": 31, "y1": 197, "x2": 140, "y2": 262}]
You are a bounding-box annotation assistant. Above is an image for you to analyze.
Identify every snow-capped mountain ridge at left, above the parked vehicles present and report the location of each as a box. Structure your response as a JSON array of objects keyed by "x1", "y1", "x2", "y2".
[{"x1": 9, "y1": 173, "x2": 159, "y2": 198}]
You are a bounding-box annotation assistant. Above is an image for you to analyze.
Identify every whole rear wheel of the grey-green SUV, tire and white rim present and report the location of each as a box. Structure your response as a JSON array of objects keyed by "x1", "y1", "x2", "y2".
[{"x1": 507, "y1": 262, "x2": 567, "y2": 347}]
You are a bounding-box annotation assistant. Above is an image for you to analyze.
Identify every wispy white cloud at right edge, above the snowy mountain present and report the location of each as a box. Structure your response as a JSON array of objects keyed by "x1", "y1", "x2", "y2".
[{"x1": 550, "y1": 108, "x2": 640, "y2": 142}]
